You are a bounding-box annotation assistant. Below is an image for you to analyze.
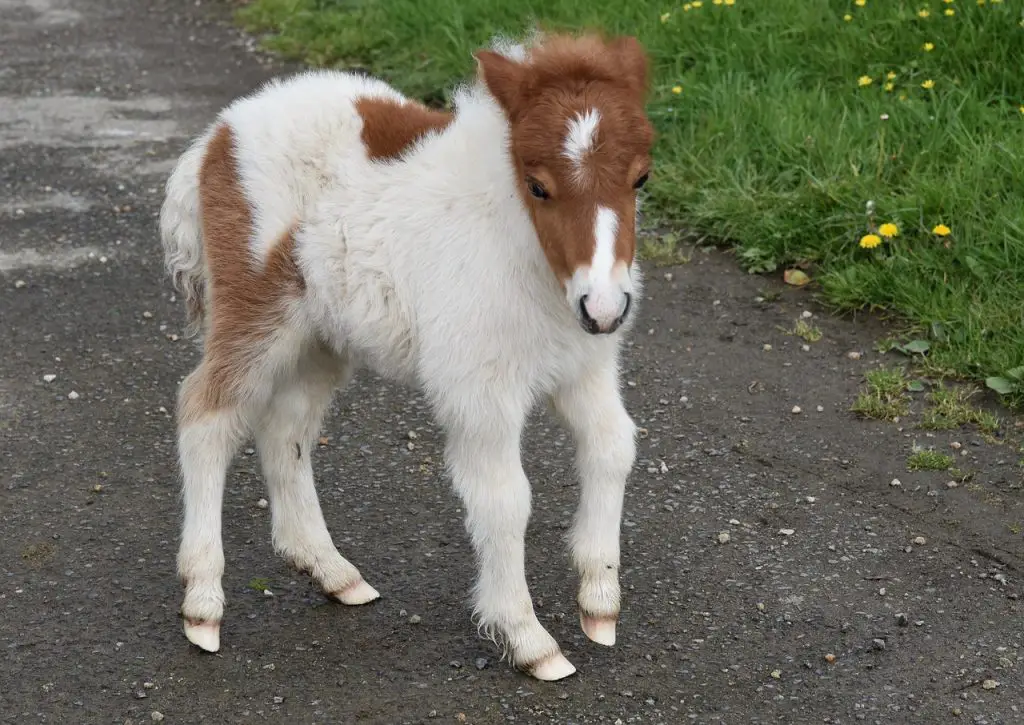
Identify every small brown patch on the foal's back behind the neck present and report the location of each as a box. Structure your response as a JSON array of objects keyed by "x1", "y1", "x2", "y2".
[{"x1": 355, "y1": 96, "x2": 452, "y2": 161}]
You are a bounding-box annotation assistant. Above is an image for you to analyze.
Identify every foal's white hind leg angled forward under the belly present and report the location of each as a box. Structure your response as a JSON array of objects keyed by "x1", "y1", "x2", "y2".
[{"x1": 256, "y1": 349, "x2": 380, "y2": 604}]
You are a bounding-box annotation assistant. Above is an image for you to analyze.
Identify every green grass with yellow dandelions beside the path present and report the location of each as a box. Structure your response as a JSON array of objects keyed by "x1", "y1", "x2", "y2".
[{"x1": 234, "y1": 0, "x2": 1024, "y2": 408}]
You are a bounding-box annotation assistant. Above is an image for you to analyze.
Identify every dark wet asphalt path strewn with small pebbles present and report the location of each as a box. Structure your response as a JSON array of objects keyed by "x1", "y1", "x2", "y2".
[{"x1": 0, "y1": 0, "x2": 1024, "y2": 725}]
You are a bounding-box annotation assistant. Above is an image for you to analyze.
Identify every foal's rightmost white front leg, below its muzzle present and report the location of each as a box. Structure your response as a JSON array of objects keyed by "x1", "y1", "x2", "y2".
[{"x1": 553, "y1": 364, "x2": 636, "y2": 646}]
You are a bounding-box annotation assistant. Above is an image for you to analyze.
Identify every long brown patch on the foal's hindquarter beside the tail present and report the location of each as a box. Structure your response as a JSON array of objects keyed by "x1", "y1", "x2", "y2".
[{"x1": 178, "y1": 125, "x2": 305, "y2": 422}]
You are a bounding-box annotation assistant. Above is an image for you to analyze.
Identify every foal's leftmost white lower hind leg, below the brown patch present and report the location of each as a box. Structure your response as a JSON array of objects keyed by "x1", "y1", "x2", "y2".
[{"x1": 178, "y1": 369, "x2": 244, "y2": 652}]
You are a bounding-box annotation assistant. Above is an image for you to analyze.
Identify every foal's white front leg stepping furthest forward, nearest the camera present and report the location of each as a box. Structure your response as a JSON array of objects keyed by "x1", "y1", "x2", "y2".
[{"x1": 446, "y1": 407, "x2": 575, "y2": 680}]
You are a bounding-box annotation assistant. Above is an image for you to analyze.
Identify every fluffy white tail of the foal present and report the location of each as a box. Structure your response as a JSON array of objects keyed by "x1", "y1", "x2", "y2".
[{"x1": 160, "y1": 133, "x2": 210, "y2": 337}]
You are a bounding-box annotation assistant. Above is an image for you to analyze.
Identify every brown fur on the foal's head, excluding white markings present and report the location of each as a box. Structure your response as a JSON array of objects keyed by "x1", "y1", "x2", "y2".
[{"x1": 476, "y1": 35, "x2": 654, "y2": 284}]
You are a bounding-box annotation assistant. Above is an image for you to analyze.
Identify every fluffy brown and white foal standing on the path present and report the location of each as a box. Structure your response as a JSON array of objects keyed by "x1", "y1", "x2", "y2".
[{"x1": 161, "y1": 35, "x2": 653, "y2": 680}]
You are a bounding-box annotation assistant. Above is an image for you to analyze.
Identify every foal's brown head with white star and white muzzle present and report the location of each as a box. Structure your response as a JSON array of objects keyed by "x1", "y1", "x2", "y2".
[{"x1": 476, "y1": 36, "x2": 653, "y2": 334}]
